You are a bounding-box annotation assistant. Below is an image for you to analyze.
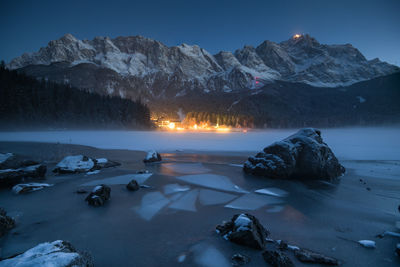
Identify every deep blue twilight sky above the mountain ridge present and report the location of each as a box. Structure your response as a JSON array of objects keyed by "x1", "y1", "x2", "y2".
[{"x1": 0, "y1": 0, "x2": 400, "y2": 65}]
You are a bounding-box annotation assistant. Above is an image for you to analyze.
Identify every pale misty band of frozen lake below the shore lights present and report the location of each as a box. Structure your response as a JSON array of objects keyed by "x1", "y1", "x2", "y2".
[{"x1": 0, "y1": 127, "x2": 400, "y2": 160}]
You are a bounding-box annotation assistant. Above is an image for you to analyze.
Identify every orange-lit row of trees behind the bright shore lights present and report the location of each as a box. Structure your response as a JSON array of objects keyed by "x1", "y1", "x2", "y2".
[{"x1": 184, "y1": 112, "x2": 254, "y2": 128}]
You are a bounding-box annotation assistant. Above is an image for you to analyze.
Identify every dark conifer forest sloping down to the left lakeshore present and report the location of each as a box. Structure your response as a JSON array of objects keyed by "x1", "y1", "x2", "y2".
[{"x1": 0, "y1": 63, "x2": 150, "y2": 128}]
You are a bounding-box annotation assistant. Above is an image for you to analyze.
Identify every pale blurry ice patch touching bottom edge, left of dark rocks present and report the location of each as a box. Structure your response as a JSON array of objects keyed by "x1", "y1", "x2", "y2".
[{"x1": 192, "y1": 244, "x2": 231, "y2": 267}]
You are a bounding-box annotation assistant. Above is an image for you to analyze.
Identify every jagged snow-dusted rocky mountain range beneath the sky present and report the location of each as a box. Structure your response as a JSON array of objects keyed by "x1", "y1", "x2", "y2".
[{"x1": 7, "y1": 34, "x2": 400, "y2": 100}]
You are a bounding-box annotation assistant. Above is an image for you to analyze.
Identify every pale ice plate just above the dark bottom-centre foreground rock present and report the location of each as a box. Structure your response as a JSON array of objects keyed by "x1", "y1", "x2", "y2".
[{"x1": 225, "y1": 193, "x2": 282, "y2": 210}]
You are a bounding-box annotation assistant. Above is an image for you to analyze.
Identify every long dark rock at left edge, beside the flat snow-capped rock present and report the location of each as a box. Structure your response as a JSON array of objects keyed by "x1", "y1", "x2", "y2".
[{"x1": 0, "y1": 162, "x2": 47, "y2": 187}]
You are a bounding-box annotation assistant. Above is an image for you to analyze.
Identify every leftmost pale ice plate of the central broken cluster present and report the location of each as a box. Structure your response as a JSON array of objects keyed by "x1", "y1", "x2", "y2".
[{"x1": 132, "y1": 192, "x2": 170, "y2": 221}]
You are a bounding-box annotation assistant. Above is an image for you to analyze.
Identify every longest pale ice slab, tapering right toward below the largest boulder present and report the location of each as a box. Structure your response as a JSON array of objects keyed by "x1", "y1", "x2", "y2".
[{"x1": 177, "y1": 174, "x2": 248, "y2": 193}]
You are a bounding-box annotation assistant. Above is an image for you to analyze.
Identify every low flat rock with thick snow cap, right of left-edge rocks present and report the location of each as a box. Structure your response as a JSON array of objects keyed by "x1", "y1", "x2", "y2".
[{"x1": 53, "y1": 155, "x2": 121, "y2": 174}]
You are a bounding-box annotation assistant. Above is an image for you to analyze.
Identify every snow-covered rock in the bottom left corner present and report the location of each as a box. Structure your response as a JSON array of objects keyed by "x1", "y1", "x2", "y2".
[{"x1": 0, "y1": 240, "x2": 94, "y2": 267}]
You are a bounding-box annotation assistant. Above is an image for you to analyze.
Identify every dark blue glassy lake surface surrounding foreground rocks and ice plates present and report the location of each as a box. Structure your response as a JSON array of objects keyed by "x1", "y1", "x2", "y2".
[{"x1": 0, "y1": 142, "x2": 400, "y2": 267}]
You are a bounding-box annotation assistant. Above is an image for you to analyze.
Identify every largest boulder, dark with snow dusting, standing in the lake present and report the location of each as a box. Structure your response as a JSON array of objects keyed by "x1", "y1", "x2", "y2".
[{"x1": 243, "y1": 128, "x2": 345, "y2": 181}]
